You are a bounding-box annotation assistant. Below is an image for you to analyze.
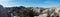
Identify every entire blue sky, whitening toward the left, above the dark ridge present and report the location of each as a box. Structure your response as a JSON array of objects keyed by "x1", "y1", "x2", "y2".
[{"x1": 0, "y1": 0, "x2": 60, "y2": 7}]
